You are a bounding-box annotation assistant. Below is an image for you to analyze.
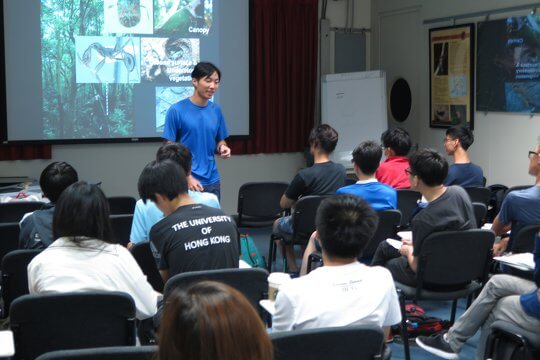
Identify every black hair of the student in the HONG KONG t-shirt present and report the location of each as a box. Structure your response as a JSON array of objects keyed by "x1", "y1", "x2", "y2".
[{"x1": 138, "y1": 160, "x2": 188, "y2": 202}]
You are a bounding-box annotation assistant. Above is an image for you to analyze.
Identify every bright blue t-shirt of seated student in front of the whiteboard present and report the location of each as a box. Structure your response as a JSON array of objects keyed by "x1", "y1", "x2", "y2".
[{"x1": 337, "y1": 181, "x2": 397, "y2": 211}]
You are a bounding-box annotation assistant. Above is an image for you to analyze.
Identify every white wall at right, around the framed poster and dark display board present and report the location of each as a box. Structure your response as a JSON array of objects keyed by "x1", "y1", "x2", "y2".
[{"x1": 371, "y1": 0, "x2": 540, "y2": 186}]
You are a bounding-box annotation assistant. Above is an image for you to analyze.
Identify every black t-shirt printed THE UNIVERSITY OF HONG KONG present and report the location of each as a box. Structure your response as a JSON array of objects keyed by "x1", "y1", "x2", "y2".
[{"x1": 149, "y1": 204, "x2": 240, "y2": 276}]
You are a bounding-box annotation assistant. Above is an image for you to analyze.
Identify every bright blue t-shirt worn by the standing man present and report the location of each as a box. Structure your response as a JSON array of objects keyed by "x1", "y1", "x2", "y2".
[{"x1": 163, "y1": 98, "x2": 229, "y2": 185}]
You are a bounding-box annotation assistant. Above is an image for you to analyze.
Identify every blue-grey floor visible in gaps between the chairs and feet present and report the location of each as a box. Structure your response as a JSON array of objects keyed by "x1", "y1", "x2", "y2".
[{"x1": 240, "y1": 229, "x2": 479, "y2": 360}]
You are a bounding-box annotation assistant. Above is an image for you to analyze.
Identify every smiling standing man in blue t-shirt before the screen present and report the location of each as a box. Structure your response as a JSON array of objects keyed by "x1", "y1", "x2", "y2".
[{"x1": 163, "y1": 62, "x2": 231, "y2": 199}]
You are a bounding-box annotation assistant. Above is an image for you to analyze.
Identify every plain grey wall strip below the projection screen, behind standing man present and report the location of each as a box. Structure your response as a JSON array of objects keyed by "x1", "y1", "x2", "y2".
[{"x1": 0, "y1": 143, "x2": 305, "y2": 214}]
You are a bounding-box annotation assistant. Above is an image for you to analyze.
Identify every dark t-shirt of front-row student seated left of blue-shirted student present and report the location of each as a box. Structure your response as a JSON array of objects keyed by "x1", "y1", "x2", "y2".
[{"x1": 285, "y1": 161, "x2": 346, "y2": 200}]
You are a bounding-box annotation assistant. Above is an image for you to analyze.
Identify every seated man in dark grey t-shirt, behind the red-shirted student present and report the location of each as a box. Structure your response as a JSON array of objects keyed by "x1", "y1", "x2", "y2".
[{"x1": 371, "y1": 149, "x2": 476, "y2": 286}]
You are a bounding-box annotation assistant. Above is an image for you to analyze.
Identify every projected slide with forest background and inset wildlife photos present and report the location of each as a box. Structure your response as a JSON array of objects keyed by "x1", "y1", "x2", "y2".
[{"x1": 40, "y1": 0, "x2": 214, "y2": 139}]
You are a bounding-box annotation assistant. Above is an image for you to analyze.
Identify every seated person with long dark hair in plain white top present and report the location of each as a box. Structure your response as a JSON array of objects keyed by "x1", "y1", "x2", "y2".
[{"x1": 28, "y1": 181, "x2": 159, "y2": 319}]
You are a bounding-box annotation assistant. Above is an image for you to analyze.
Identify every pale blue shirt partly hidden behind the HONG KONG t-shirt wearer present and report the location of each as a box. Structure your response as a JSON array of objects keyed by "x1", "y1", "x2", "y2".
[{"x1": 129, "y1": 190, "x2": 220, "y2": 244}]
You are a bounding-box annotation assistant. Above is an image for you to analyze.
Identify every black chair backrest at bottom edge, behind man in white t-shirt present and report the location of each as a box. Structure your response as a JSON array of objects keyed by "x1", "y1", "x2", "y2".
[{"x1": 270, "y1": 325, "x2": 384, "y2": 360}]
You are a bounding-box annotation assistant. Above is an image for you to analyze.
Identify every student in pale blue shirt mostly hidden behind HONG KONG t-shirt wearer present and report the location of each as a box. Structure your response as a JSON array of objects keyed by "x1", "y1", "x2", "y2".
[{"x1": 129, "y1": 143, "x2": 220, "y2": 244}]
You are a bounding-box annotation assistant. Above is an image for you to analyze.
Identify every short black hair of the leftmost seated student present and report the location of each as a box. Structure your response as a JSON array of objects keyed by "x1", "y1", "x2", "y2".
[{"x1": 39, "y1": 161, "x2": 79, "y2": 204}]
